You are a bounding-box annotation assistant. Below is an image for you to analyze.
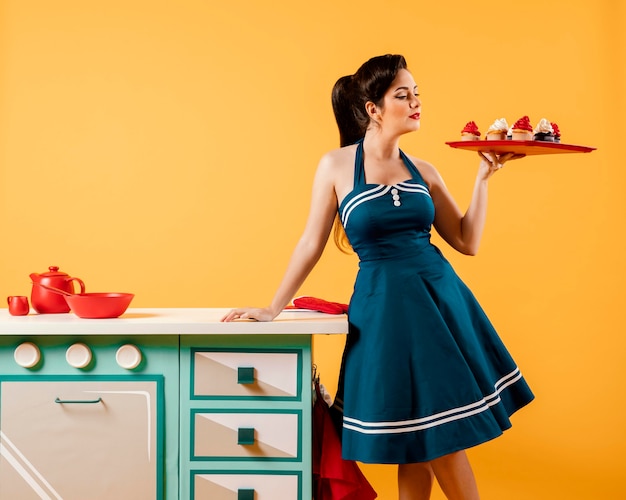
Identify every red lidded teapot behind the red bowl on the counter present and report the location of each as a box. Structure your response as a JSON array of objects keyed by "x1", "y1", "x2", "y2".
[{"x1": 30, "y1": 266, "x2": 85, "y2": 314}]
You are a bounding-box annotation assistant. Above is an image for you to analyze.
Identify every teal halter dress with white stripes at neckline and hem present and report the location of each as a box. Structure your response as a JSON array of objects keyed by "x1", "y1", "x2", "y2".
[{"x1": 333, "y1": 142, "x2": 534, "y2": 464}]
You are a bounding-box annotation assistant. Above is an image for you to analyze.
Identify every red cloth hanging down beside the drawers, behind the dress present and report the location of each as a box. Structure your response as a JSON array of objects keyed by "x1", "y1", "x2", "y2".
[{"x1": 313, "y1": 383, "x2": 378, "y2": 500}]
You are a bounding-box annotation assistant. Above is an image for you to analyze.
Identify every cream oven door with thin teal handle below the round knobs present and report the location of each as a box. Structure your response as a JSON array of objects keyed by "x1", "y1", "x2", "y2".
[{"x1": 0, "y1": 376, "x2": 163, "y2": 500}]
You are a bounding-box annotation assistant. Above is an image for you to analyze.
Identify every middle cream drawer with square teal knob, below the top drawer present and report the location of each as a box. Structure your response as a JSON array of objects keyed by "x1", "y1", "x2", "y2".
[{"x1": 191, "y1": 410, "x2": 302, "y2": 460}]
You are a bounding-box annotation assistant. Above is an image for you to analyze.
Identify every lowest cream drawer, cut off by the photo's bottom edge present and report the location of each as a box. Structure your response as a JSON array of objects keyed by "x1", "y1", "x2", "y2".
[{"x1": 192, "y1": 472, "x2": 302, "y2": 500}]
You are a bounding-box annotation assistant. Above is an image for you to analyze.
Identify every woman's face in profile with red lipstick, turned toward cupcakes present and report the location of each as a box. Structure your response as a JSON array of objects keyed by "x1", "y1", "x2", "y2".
[{"x1": 377, "y1": 69, "x2": 422, "y2": 134}]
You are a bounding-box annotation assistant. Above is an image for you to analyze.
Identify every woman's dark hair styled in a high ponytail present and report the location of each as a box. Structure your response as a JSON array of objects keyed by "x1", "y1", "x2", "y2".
[{"x1": 332, "y1": 54, "x2": 406, "y2": 147}]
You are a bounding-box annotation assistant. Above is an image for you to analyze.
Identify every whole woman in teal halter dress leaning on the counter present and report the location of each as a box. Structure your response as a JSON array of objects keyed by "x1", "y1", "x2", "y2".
[{"x1": 224, "y1": 55, "x2": 533, "y2": 500}]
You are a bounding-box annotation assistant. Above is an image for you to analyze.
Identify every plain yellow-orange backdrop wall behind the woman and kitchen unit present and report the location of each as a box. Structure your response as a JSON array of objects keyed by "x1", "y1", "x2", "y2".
[{"x1": 0, "y1": 0, "x2": 626, "y2": 500}]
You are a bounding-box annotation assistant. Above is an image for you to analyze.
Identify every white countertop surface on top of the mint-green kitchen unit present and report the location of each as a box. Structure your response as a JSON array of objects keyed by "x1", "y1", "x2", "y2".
[{"x1": 0, "y1": 308, "x2": 348, "y2": 335}]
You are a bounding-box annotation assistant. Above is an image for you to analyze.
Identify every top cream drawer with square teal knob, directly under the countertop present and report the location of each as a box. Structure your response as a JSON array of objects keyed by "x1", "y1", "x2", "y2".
[{"x1": 191, "y1": 349, "x2": 302, "y2": 400}]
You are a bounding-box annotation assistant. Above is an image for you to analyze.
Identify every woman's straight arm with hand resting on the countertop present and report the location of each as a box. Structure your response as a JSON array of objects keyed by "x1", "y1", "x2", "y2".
[{"x1": 222, "y1": 156, "x2": 337, "y2": 321}]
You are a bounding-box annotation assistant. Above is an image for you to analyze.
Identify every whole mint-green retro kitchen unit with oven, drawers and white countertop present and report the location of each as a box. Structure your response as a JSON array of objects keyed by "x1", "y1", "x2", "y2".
[{"x1": 0, "y1": 308, "x2": 348, "y2": 500}]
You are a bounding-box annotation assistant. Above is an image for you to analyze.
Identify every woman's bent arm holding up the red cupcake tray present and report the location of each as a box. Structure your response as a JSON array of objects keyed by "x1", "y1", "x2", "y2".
[{"x1": 429, "y1": 153, "x2": 522, "y2": 255}]
